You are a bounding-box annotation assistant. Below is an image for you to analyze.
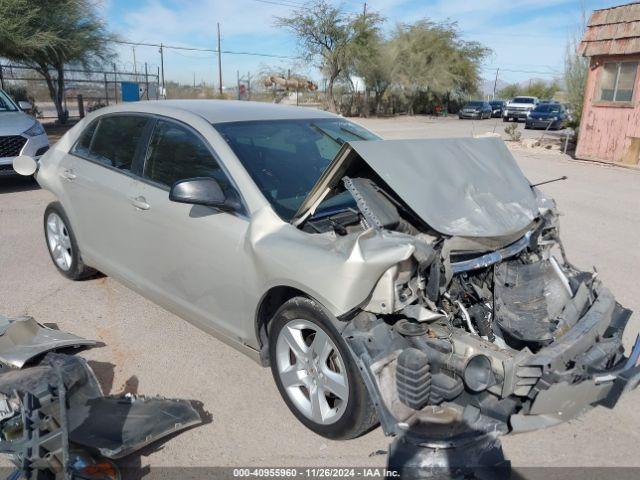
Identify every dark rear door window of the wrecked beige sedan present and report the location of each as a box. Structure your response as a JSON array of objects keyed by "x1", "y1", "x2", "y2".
[{"x1": 73, "y1": 115, "x2": 148, "y2": 170}]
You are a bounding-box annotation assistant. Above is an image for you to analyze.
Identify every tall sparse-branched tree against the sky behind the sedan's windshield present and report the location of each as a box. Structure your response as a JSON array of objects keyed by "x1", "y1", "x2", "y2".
[{"x1": 276, "y1": 0, "x2": 380, "y2": 112}]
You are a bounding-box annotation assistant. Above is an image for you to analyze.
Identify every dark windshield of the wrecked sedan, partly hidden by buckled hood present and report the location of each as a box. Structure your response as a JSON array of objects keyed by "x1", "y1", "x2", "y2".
[{"x1": 214, "y1": 118, "x2": 379, "y2": 221}]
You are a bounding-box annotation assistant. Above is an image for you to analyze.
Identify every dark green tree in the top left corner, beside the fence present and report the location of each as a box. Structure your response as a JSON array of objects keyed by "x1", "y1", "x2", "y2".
[{"x1": 0, "y1": 0, "x2": 115, "y2": 123}]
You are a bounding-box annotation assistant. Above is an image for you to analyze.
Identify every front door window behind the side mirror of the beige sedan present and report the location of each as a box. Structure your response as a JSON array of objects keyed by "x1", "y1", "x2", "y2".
[{"x1": 143, "y1": 120, "x2": 229, "y2": 190}]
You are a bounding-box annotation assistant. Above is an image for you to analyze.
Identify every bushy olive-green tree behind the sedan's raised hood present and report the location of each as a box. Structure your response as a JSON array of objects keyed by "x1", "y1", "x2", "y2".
[{"x1": 391, "y1": 19, "x2": 490, "y2": 113}]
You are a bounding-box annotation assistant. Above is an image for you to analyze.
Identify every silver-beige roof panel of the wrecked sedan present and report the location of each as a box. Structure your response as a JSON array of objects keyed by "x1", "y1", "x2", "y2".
[{"x1": 101, "y1": 100, "x2": 339, "y2": 123}]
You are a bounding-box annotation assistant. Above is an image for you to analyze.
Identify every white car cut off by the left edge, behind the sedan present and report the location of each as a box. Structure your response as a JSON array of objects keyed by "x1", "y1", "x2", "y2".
[{"x1": 0, "y1": 90, "x2": 49, "y2": 175}]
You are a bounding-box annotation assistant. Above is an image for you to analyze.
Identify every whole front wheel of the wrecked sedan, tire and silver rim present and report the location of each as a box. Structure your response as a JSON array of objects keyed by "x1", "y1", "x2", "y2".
[{"x1": 269, "y1": 297, "x2": 378, "y2": 440}]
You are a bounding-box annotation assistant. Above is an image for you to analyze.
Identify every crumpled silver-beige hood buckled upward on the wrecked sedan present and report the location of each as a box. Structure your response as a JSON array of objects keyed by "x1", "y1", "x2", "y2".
[{"x1": 294, "y1": 137, "x2": 538, "y2": 237}]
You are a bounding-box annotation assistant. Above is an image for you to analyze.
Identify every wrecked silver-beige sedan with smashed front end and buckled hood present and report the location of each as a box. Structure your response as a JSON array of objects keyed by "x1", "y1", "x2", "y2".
[{"x1": 16, "y1": 100, "x2": 640, "y2": 438}]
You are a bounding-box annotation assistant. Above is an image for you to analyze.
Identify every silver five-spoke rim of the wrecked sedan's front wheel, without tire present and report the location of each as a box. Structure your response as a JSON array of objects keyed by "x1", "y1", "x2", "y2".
[{"x1": 276, "y1": 319, "x2": 349, "y2": 425}]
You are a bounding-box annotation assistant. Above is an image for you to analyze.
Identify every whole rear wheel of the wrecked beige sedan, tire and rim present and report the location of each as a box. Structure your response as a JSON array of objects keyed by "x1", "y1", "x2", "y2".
[{"x1": 44, "y1": 202, "x2": 96, "y2": 280}]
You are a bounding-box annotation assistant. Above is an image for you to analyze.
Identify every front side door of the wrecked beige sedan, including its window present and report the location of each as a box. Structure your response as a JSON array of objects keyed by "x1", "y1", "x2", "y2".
[{"x1": 133, "y1": 118, "x2": 253, "y2": 340}]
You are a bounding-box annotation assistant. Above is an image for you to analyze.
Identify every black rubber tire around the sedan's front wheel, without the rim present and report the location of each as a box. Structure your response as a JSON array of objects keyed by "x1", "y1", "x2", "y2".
[{"x1": 269, "y1": 297, "x2": 378, "y2": 440}]
